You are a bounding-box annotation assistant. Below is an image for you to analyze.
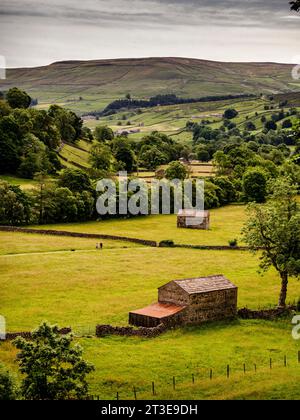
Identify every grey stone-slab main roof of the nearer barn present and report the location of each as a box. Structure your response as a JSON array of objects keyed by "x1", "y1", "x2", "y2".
[{"x1": 160, "y1": 274, "x2": 237, "y2": 295}]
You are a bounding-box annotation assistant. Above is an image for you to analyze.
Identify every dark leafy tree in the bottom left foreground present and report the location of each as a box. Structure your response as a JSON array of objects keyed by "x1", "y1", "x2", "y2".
[{"x1": 14, "y1": 323, "x2": 94, "y2": 400}]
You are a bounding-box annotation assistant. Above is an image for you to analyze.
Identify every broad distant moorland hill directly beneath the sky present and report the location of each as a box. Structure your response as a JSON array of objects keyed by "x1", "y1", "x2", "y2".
[{"x1": 0, "y1": 58, "x2": 300, "y2": 112}]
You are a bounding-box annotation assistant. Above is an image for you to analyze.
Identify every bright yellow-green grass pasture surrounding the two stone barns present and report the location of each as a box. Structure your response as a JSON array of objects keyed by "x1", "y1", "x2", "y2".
[{"x1": 0, "y1": 206, "x2": 300, "y2": 399}]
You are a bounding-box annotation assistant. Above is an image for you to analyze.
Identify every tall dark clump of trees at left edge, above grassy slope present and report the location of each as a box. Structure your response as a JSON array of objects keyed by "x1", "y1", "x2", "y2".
[{"x1": 0, "y1": 89, "x2": 82, "y2": 179}]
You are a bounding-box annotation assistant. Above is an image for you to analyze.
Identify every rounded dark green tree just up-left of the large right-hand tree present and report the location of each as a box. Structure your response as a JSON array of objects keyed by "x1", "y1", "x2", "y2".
[{"x1": 243, "y1": 168, "x2": 267, "y2": 203}]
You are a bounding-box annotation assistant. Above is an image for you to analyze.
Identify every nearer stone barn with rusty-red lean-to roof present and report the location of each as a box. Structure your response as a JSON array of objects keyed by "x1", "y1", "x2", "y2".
[{"x1": 129, "y1": 274, "x2": 238, "y2": 328}]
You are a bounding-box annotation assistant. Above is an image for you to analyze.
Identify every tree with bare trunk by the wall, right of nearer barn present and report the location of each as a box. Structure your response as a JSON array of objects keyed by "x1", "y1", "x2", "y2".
[{"x1": 243, "y1": 178, "x2": 300, "y2": 308}]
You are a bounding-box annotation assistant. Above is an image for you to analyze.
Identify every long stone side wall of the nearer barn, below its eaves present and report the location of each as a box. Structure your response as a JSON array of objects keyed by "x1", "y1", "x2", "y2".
[{"x1": 183, "y1": 289, "x2": 237, "y2": 325}]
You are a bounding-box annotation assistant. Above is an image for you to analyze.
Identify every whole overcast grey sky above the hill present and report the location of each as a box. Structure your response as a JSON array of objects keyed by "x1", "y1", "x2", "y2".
[{"x1": 0, "y1": 0, "x2": 300, "y2": 67}]
